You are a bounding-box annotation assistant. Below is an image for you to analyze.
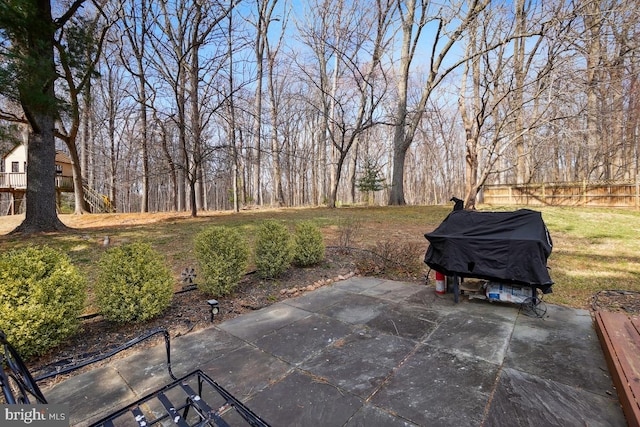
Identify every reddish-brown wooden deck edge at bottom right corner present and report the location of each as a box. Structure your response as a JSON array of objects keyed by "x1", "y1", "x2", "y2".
[{"x1": 595, "y1": 311, "x2": 640, "y2": 427}]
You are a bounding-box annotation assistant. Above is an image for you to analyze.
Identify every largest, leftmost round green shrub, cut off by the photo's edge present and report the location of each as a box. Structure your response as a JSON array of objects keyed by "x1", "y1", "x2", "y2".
[{"x1": 0, "y1": 246, "x2": 86, "y2": 359}]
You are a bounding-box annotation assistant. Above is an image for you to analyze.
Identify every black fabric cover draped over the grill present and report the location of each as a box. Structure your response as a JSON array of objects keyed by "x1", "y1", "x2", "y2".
[{"x1": 424, "y1": 209, "x2": 553, "y2": 293}]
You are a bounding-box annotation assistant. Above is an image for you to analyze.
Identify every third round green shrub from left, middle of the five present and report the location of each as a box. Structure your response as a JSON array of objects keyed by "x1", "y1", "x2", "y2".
[{"x1": 194, "y1": 227, "x2": 249, "y2": 296}]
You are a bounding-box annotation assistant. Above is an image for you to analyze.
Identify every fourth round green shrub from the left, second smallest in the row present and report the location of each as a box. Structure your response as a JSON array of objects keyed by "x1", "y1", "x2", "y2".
[{"x1": 256, "y1": 220, "x2": 293, "y2": 279}]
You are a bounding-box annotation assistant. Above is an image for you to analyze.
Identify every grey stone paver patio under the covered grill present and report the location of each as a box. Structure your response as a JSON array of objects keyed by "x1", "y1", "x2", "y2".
[{"x1": 44, "y1": 277, "x2": 626, "y2": 427}]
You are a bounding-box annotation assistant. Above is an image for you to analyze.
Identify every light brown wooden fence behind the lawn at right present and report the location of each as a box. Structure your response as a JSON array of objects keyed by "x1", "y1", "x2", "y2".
[{"x1": 481, "y1": 177, "x2": 640, "y2": 209}]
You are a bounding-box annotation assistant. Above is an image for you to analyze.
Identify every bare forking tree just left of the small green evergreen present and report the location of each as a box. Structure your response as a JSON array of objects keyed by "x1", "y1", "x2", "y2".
[{"x1": 296, "y1": 0, "x2": 394, "y2": 207}]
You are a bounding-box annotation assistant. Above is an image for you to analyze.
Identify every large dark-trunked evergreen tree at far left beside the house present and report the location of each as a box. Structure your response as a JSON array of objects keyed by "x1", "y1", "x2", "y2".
[{"x1": 0, "y1": 0, "x2": 85, "y2": 233}]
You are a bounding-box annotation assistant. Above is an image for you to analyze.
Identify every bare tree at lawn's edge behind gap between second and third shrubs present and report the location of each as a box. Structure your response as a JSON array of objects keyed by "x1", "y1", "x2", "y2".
[{"x1": 151, "y1": 0, "x2": 233, "y2": 216}]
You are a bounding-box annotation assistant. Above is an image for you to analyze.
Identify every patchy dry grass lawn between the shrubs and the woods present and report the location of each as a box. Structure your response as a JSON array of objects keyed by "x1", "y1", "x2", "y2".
[{"x1": 0, "y1": 206, "x2": 640, "y2": 308}]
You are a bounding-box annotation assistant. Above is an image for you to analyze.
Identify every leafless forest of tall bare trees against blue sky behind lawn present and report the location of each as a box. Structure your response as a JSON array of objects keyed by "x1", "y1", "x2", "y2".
[{"x1": 2, "y1": 0, "x2": 640, "y2": 214}]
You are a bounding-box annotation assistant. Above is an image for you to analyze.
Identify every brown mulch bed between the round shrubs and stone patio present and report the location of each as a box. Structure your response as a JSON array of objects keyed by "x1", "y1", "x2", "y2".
[{"x1": 27, "y1": 248, "x2": 364, "y2": 377}]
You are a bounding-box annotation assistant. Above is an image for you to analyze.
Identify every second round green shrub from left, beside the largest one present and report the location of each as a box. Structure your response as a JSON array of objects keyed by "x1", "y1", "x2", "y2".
[{"x1": 94, "y1": 243, "x2": 173, "y2": 323}]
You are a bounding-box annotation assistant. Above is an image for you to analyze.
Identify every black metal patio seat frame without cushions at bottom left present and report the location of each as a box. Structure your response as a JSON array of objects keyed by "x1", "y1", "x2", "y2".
[{"x1": 0, "y1": 328, "x2": 268, "y2": 427}]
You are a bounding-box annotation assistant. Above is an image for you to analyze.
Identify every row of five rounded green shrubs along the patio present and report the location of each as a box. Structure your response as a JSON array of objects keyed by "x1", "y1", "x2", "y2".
[{"x1": 0, "y1": 220, "x2": 324, "y2": 358}]
